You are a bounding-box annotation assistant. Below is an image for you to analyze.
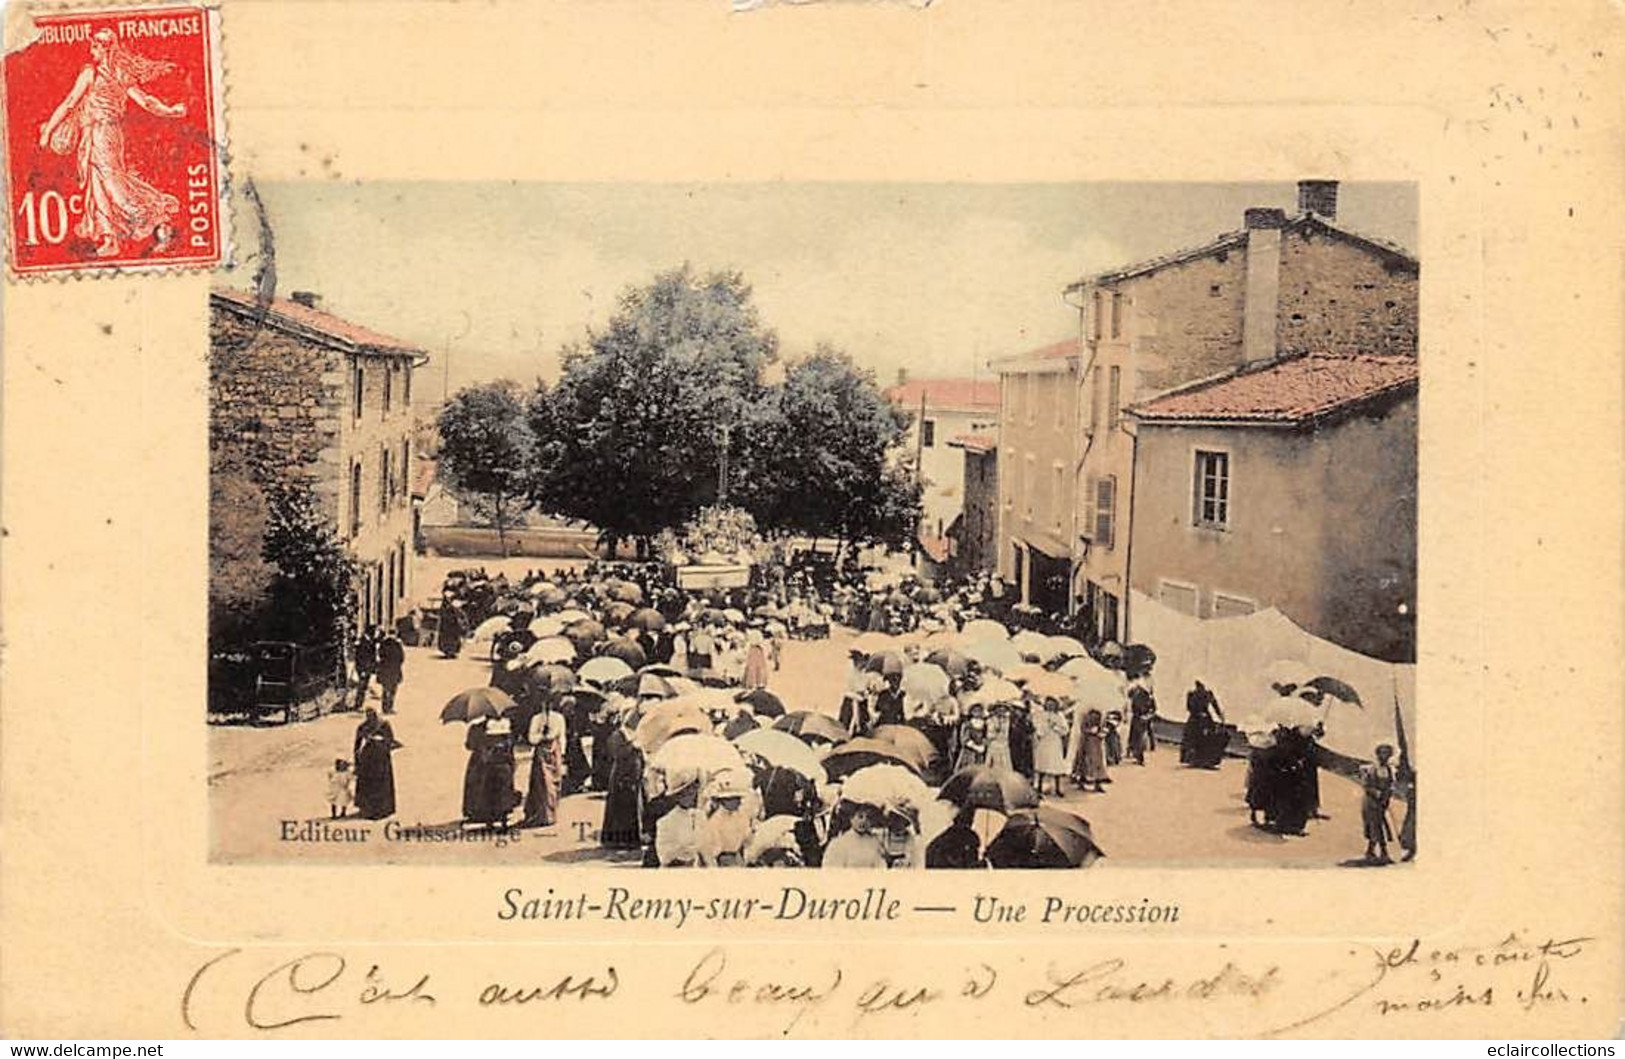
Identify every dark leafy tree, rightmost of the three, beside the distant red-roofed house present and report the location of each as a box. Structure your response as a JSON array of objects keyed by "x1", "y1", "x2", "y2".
[{"x1": 751, "y1": 344, "x2": 920, "y2": 547}]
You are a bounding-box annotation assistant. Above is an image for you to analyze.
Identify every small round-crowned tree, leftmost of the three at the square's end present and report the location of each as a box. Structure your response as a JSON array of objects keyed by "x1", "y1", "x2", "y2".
[{"x1": 437, "y1": 378, "x2": 535, "y2": 555}]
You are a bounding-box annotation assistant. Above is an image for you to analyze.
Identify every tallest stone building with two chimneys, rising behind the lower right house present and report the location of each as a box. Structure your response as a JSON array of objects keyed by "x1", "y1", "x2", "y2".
[{"x1": 1059, "y1": 180, "x2": 1419, "y2": 640}]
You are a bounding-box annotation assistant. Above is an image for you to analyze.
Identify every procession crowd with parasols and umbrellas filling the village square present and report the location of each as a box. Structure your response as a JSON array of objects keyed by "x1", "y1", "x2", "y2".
[{"x1": 326, "y1": 562, "x2": 1414, "y2": 867}]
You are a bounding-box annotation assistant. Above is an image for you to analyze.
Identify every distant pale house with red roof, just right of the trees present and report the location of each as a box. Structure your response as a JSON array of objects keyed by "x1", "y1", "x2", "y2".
[{"x1": 886, "y1": 378, "x2": 999, "y2": 541}]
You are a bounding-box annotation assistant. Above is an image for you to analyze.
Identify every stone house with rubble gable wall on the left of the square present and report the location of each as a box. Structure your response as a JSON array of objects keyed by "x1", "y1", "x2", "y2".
[{"x1": 210, "y1": 289, "x2": 426, "y2": 624}]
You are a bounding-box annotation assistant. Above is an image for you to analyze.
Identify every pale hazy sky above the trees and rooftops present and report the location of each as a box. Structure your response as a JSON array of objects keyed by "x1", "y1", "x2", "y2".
[{"x1": 237, "y1": 182, "x2": 1417, "y2": 398}]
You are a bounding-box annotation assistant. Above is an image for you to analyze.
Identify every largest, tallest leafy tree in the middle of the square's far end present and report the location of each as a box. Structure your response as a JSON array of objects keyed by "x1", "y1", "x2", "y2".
[{"x1": 530, "y1": 265, "x2": 778, "y2": 552}]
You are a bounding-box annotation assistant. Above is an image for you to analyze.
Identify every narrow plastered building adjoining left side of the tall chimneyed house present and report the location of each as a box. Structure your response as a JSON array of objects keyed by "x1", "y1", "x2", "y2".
[{"x1": 993, "y1": 338, "x2": 1081, "y2": 612}]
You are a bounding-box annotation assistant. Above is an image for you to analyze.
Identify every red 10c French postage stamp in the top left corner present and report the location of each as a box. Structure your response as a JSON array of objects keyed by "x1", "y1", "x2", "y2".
[{"x1": 5, "y1": 5, "x2": 229, "y2": 274}]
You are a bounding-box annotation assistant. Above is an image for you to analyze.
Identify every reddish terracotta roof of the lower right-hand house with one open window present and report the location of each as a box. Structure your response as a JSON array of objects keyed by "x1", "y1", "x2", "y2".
[{"x1": 1129, "y1": 354, "x2": 1417, "y2": 426}]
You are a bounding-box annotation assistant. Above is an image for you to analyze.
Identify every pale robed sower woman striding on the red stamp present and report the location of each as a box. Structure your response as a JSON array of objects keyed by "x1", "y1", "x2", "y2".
[{"x1": 39, "y1": 29, "x2": 187, "y2": 257}]
